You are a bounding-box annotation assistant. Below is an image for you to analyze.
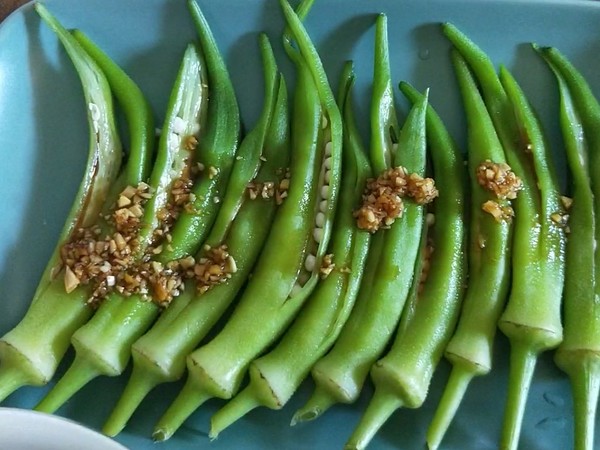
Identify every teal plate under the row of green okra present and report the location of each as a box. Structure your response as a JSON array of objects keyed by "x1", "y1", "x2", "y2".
[{"x1": 0, "y1": 0, "x2": 600, "y2": 450}]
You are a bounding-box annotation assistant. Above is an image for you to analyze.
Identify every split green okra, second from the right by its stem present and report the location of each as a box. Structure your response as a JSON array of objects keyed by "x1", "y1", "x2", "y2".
[{"x1": 443, "y1": 24, "x2": 565, "y2": 449}]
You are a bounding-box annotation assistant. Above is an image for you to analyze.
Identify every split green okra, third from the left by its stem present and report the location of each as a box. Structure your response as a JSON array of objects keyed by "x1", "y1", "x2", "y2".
[{"x1": 103, "y1": 35, "x2": 289, "y2": 436}]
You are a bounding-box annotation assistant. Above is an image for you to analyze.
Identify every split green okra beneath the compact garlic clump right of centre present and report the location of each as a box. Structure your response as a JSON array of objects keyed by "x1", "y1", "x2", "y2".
[{"x1": 292, "y1": 14, "x2": 425, "y2": 423}]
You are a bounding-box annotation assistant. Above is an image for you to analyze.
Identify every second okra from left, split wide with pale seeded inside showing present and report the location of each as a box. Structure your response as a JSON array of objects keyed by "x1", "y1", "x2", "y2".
[{"x1": 36, "y1": 0, "x2": 239, "y2": 412}]
